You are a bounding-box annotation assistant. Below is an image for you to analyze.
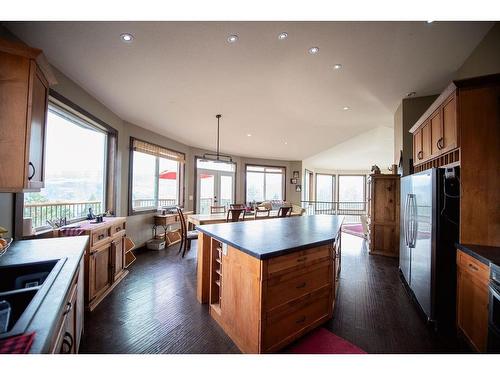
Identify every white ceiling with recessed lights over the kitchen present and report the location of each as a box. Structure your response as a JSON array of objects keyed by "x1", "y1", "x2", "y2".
[{"x1": 6, "y1": 22, "x2": 492, "y2": 165}]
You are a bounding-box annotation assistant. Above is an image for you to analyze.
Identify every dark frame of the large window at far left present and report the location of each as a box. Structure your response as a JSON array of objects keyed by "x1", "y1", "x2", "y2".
[{"x1": 13, "y1": 89, "x2": 118, "y2": 240}]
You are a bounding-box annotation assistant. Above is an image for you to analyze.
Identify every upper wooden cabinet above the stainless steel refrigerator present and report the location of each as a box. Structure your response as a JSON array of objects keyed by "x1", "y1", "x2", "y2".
[{"x1": 410, "y1": 86, "x2": 459, "y2": 165}]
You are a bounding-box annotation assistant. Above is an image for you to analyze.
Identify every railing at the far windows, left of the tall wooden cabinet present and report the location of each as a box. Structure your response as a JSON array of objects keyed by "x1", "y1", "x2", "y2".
[{"x1": 301, "y1": 201, "x2": 368, "y2": 223}]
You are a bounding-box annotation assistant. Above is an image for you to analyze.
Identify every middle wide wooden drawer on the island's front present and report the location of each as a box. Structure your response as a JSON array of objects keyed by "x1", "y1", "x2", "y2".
[{"x1": 264, "y1": 260, "x2": 333, "y2": 311}]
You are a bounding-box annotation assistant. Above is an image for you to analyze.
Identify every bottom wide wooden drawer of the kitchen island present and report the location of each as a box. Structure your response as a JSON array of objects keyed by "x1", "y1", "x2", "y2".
[{"x1": 263, "y1": 288, "x2": 331, "y2": 351}]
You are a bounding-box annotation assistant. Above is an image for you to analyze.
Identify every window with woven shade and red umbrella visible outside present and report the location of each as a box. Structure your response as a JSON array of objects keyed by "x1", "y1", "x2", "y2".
[{"x1": 129, "y1": 138, "x2": 185, "y2": 214}]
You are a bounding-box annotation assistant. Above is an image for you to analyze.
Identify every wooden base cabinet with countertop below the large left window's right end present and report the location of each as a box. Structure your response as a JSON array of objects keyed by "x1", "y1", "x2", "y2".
[{"x1": 58, "y1": 217, "x2": 133, "y2": 311}]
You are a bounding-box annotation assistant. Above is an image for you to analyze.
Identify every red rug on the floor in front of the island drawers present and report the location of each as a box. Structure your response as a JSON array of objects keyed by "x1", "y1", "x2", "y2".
[{"x1": 288, "y1": 328, "x2": 366, "y2": 354}]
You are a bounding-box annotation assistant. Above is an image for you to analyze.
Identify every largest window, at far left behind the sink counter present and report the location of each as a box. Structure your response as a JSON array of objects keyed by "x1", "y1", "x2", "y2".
[{"x1": 23, "y1": 102, "x2": 108, "y2": 230}]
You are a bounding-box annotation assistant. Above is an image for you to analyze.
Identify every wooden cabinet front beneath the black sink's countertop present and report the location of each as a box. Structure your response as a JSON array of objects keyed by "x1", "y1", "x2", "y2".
[{"x1": 51, "y1": 258, "x2": 84, "y2": 354}]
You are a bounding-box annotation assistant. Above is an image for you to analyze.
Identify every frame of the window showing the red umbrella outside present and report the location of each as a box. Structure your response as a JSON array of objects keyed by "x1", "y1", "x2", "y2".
[{"x1": 127, "y1": 137, "x2": 186, "y2": 216}]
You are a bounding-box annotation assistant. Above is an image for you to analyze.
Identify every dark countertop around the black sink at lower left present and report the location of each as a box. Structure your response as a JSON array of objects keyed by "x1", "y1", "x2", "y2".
[{"x1": 0, "y1": 236, "x2": 88, "y2": 353}]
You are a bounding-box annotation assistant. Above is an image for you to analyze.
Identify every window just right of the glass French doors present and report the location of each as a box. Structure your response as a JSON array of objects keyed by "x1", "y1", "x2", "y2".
[{"x1": 246, "y1": 165, "x2": 286, "y2": 202}]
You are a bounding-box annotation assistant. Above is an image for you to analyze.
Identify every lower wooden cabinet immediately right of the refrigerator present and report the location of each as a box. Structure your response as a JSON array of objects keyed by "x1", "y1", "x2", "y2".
[{"x1": 457, "y1": 250, "x2": 489, "y2": 352}]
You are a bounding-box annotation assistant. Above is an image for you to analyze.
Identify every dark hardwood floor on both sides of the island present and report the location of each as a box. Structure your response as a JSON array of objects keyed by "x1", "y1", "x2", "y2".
[{"x1": 80, "y1": 234, "x2": 464, "y2": 353}]
